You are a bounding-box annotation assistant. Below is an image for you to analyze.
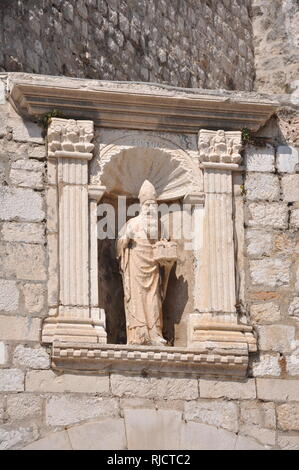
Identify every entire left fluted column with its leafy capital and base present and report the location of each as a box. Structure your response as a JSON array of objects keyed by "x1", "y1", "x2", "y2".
[{"x1": 43, "y1": 118, "x2": 105, "y2": 342}]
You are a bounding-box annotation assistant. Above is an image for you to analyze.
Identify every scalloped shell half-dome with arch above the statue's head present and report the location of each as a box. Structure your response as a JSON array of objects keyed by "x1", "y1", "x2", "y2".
[{"x1": 90, "y1": 133, "x2": 203, "y2": 201}]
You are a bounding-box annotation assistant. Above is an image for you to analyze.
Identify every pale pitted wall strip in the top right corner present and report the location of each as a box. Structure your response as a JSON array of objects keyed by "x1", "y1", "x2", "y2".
[{"x1": 252, "y1": 0, "x2": 299, "y2": 93}]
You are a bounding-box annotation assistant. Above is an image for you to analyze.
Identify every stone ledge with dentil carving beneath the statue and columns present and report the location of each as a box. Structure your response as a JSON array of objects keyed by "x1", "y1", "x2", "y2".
[{"x1": 52, "y1": 342, "x2": 252, "y2": 377}]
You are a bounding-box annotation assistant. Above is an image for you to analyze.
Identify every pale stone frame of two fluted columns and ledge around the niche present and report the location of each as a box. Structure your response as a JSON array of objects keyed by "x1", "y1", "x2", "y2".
[{"x1": 42, "y1": 118, "x2": 256, "y2": 375}]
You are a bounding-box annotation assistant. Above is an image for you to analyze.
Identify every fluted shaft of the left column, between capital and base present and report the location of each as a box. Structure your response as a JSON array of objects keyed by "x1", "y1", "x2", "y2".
[{"x1": 58, "y1": 154, "x2": 89, "y2": 318}]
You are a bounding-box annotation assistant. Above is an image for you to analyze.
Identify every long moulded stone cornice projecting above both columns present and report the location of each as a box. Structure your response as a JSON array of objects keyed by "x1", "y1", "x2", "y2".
[{"x1": 9, "y1": 73, "x2": 279, "y2": 134}]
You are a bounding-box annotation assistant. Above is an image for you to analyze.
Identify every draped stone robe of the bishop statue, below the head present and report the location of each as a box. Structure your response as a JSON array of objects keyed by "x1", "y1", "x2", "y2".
[{"x1": 117, "y1": 214, "x2": 164, "y2": 344}]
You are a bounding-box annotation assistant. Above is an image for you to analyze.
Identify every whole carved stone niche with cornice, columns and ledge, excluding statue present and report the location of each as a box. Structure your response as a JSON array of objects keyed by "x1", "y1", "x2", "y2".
[{"x1": 11, "y1": 77, "x2": 277, "y2": 377}]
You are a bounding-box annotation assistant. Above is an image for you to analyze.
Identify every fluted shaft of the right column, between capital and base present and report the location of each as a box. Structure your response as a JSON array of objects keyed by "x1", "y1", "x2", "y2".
[{"x1": 198, "y1": 167, "x2": 236, "y2": 322}]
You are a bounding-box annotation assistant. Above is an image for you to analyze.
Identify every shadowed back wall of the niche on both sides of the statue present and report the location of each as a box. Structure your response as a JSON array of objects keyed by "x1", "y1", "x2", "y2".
[{"x1": 98, "y1": 196, "x2": 194, "y2": 347}]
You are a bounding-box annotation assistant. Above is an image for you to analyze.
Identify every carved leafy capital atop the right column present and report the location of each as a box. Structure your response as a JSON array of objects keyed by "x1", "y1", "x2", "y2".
[{"x1": 198, "y1": 129, "x2": 242, "y2": 167}]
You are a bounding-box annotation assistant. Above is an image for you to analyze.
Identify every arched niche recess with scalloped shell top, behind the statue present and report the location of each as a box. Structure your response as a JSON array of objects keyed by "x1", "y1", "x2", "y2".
[{"x1": 90, "y1": 134, "x2": 202, "y2": 346}]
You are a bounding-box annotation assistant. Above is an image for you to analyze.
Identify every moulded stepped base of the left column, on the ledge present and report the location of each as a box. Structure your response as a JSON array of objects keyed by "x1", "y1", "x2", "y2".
[{"x1": 42, "y1": 310, "x2": 107, "y2": 344}]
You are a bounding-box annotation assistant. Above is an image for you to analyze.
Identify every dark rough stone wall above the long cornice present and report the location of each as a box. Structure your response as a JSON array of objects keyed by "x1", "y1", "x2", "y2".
[{"x1": 0, "y1": 0, "x2": 254, "y2": 90}]
